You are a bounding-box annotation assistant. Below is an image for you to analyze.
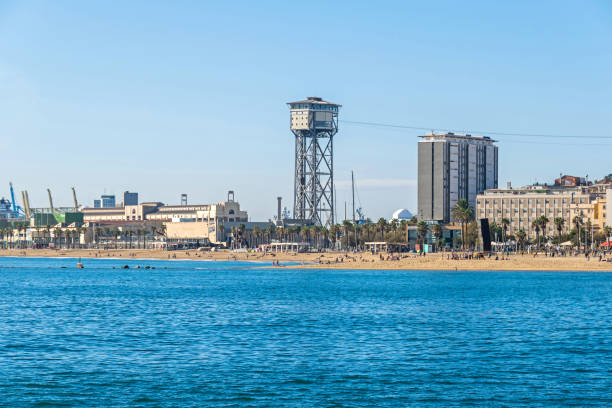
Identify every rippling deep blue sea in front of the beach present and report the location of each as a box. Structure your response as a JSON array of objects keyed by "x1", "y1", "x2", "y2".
[{"x1": 0, "y1": 258, "x2": 612, "y2": 407}]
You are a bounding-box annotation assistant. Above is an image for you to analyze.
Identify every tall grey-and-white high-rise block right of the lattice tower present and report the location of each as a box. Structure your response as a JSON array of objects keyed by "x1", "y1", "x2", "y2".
[{"x1": 418, "y1": 132, "x2": 497, "y2": 222}]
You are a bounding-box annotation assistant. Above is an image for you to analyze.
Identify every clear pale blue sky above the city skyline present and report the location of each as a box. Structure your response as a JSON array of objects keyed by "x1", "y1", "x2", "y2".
[{"x1": 0, "y1": 1, "x2": 612, "y2": 220}]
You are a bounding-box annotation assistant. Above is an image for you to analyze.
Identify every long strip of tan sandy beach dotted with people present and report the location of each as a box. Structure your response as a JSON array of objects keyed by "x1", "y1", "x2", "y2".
[{"x1": 0, "y1": 249, "x2": 612, "y2": 272}]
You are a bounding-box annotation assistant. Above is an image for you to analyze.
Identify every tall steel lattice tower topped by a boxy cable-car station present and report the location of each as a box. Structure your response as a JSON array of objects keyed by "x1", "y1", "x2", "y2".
[{"x1": 288, "y1": 97, "x2": 341, "y2": 226}]
